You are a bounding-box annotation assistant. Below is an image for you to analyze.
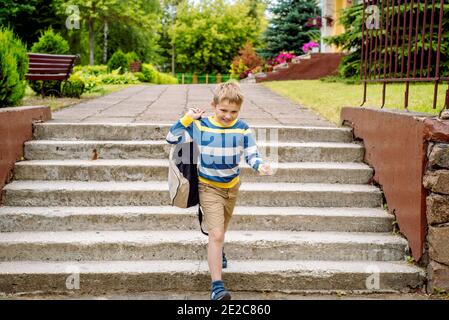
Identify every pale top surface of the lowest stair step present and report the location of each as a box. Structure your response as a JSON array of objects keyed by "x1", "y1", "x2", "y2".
[{"x1": 0, "y1": 260, "x2": 425, "y2": 277}]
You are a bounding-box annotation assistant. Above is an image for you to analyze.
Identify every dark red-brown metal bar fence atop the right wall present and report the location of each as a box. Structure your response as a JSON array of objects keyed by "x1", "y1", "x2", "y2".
[{"x1": 360, "y1": 0, "x2": 449, "y2": 115}]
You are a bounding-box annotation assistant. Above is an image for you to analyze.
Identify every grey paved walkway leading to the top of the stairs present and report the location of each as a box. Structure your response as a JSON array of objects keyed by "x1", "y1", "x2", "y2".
[{"x1": 51, "y1": 84, "x2": 335, "y2": 127}]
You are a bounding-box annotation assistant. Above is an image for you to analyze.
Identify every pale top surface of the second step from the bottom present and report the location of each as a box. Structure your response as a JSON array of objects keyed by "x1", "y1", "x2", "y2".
[{"x1": 0, "y1": 230, "x2": 407, "y2": 246}]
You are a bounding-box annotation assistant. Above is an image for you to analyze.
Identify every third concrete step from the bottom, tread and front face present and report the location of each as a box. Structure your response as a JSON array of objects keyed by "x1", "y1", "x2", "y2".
[{"x1": 0, "y1": 206, "x2": 393, "y2": 232}]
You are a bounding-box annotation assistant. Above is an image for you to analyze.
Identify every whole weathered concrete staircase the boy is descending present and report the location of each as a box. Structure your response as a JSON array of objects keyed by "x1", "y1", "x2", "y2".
[{"x1": 0, "y1": 123, "x2": 424, "y2": 297}]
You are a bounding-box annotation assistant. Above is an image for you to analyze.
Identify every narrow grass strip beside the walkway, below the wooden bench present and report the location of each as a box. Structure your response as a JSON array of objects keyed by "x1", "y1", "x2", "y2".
[{"x1": 21, "y1": 84, "x2": 138, "y2": 111}]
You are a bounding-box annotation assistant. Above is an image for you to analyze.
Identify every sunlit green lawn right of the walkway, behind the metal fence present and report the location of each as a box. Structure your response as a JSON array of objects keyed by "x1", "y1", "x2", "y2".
[{"x1": 263, "y1": 80, "x2": 447, "y2": 124}]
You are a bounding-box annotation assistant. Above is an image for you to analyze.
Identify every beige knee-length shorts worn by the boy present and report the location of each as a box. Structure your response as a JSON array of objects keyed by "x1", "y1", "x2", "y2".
[{"x1": 198, "y1": 180, "x2": 241, "y2": 230}]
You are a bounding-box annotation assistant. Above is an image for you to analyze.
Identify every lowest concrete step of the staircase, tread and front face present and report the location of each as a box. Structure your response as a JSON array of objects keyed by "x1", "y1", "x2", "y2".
[{"x1": 0, "y1": 260, "x2": 425, "y2": 295}]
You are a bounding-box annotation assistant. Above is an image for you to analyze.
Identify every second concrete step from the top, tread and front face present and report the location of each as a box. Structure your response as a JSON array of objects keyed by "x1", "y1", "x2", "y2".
[{"x1": 24, "y1": 140, "x2": 364, "y2": 162}]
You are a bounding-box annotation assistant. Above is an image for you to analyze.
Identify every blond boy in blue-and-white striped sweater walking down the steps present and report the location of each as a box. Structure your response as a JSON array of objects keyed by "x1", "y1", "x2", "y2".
[{"x1": 166, "y1": 81, "x2": 272, "y2": 300}]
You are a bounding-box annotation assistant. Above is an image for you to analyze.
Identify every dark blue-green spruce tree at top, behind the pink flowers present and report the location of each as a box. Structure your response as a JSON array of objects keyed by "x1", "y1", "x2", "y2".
[{"x1": 260, "y1": 0, "x2": 319, "y2": 58}]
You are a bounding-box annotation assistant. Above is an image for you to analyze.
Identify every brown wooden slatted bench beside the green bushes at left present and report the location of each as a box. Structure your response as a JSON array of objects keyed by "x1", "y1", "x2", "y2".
[{"x1": 26, "y1": 53, "x2": 79, "y2": 96}]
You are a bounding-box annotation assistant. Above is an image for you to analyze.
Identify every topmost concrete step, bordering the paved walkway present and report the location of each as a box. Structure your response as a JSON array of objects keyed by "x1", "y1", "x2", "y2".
[{"x1": 34, "y1": 123, "x2": 352, "y2": 142}]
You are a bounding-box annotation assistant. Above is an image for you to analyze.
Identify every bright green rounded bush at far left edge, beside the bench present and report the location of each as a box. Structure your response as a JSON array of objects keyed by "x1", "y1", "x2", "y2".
[{"x1": 0, "y1": 28, "x2": 28, "y2": 107}]
